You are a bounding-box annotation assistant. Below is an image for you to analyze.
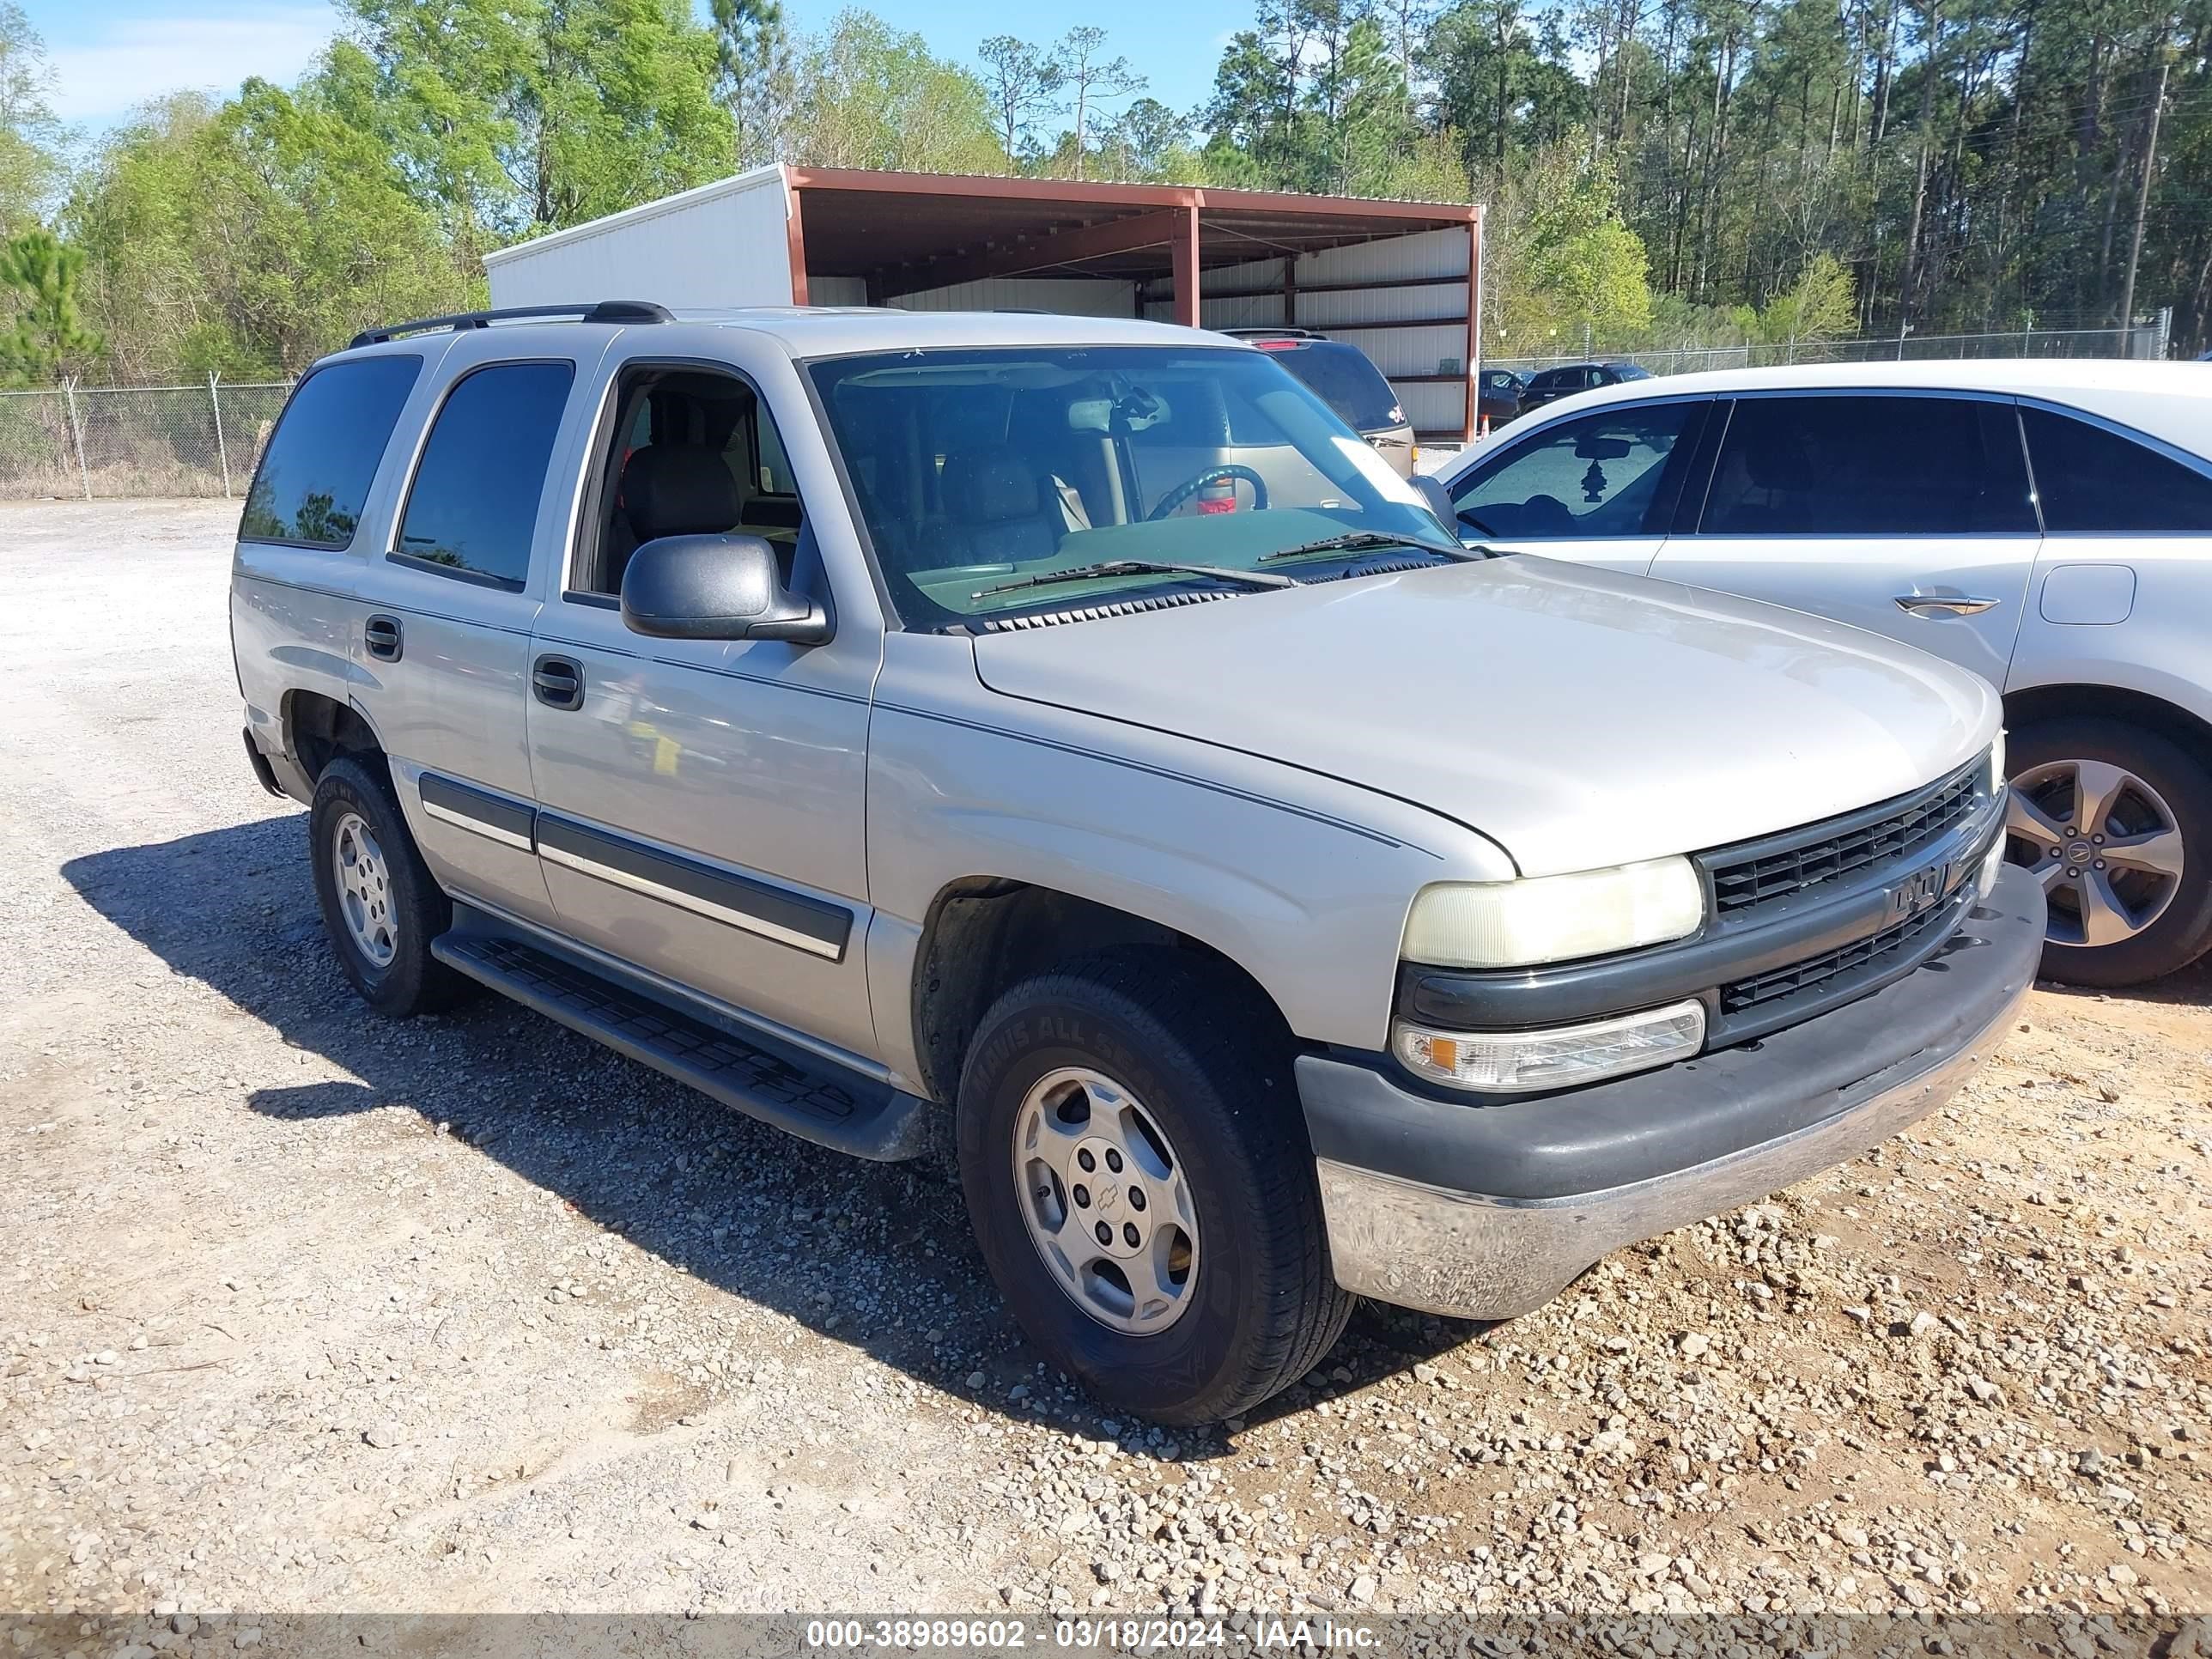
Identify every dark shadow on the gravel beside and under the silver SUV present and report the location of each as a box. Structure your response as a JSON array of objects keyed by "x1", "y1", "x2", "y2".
[{"x1": 62, "y1": 814, "x2": 1480, "y2": 1458}]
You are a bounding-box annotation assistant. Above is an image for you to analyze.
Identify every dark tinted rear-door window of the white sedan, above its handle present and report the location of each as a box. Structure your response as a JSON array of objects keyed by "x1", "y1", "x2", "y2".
[{"x1": 1704, "y1": 398, "x2": 2035, "y2": 535}]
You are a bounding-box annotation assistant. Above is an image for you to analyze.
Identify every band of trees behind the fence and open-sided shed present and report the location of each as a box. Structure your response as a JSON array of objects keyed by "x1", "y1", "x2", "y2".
[{"x1": 47, "y1": 0, "x2": 2212, "y2": 380}]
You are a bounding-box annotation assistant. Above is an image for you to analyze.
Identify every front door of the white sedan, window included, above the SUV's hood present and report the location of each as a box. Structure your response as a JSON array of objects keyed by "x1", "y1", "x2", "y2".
[{"x1": 1451, "y1": 398, "x2": 1712, "y2": 575}]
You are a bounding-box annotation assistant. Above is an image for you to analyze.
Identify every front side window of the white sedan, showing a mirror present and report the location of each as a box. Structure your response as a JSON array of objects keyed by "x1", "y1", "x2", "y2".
[{"x1": 1451, "y1": 400, "x2": 1701, "y2": 542}]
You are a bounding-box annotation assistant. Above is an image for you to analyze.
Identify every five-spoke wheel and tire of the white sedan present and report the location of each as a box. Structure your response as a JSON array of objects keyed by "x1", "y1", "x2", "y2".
[{"x1": 2006, "y1": 717, "x2": 2212, "y2": 987}]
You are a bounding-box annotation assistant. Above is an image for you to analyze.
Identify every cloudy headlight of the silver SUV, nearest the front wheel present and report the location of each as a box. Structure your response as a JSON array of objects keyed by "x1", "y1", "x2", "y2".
[{"x1": 1402, "y1": 858, "x2": 1705, "y2": 967}]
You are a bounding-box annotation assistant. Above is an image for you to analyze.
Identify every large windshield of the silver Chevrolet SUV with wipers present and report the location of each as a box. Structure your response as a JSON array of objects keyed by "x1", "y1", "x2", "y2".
[{"x1": 810, "y1": 345, "x2": 1451, "y2": 629}]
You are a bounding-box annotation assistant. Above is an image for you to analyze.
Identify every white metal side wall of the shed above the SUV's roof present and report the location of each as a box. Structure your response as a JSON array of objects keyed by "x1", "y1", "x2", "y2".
[{"x1": 484, "y1": 166, "x2": 792, "y2": 310}]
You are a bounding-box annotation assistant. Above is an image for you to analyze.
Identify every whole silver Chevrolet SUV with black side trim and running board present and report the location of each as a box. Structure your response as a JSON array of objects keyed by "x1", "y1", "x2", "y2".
[{"x1": 230, "y1": 301, "x2": 2044, "y2": 1422}]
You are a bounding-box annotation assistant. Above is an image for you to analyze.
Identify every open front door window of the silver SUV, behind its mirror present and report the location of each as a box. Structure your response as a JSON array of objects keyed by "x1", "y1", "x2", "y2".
[{"x1": 568, "y1": 365, "x2": 805, "y2": 595}]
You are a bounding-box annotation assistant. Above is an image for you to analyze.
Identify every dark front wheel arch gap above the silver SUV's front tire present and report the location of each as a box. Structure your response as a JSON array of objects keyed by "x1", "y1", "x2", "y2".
[{"x1": 909, "y1": 876, "x2": 1291, "y2": 1102}]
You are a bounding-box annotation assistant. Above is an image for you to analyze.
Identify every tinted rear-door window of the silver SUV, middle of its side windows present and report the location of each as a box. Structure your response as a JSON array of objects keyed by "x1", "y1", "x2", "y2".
[{"x1": 394, "y1": 362, "x2": 575, "y2": 588}]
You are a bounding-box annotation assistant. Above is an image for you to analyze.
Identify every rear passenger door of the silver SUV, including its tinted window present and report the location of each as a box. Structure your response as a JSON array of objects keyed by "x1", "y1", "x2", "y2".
[{"x1": 340, "y1": 330, "x2": 584, "y2": 922}]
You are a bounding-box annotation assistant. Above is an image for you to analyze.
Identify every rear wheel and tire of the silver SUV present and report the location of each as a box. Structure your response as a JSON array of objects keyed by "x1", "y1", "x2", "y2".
[{"x1": 307, "y1": 754, "x2": 469, "y2": 1018}]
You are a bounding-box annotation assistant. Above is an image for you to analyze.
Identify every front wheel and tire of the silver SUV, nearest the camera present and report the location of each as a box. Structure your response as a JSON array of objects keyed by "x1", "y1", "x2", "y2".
[{"x1": 957, "y1": 947, "x2": 1354, "y2": 1425}]
